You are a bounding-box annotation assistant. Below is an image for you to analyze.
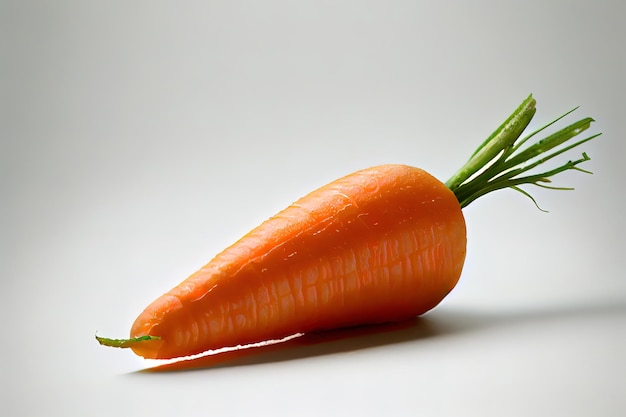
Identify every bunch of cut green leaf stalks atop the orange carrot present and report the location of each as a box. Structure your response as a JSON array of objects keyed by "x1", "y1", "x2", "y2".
[{"x1": 446, "y1": 95, "x2": 600, "y2": 207}]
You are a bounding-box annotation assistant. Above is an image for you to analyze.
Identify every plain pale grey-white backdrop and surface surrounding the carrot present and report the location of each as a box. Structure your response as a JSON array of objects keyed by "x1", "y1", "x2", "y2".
[{"x1": 0, "y1": 0, "x2": 626, "y2": 417}]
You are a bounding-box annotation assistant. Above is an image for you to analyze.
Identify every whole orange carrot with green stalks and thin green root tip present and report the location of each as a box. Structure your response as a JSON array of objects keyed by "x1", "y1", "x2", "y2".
[{"x1": 96, "y1": 95, "x2": 600, "y2": 359}]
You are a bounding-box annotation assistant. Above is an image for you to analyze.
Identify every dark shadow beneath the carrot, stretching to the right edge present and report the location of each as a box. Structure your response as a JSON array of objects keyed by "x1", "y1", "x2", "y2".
[{"x1": 136, "y1": 302, "x2": 626, "y2": 374}]
